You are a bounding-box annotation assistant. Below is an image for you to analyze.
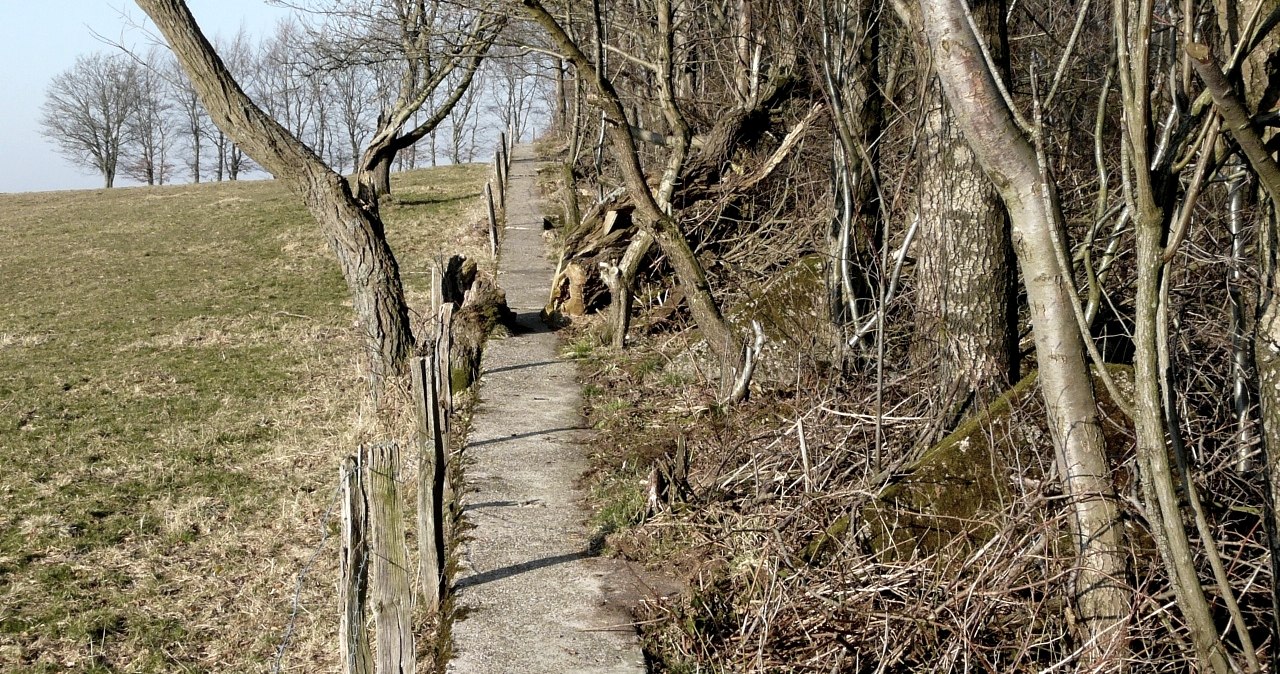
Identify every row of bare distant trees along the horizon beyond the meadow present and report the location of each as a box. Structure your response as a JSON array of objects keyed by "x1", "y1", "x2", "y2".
[{"x1": 40, "y1": 14, "x2": 544, "y2": 187}]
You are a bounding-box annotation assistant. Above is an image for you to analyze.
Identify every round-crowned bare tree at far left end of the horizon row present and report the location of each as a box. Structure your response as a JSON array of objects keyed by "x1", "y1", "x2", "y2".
[{"x1": 40, "y1": 54, "x2": 138, "y2": 187}]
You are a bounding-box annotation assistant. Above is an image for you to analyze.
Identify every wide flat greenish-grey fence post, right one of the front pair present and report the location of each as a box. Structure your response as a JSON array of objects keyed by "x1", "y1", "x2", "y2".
[{"x1": 364, "y1": 443, "x2": 417, "y2": 674}]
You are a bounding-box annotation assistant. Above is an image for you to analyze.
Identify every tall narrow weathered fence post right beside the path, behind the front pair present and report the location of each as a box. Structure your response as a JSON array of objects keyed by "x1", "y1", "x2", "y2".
[{"x1": 412, "y1": 357, "x2": 444, "y2": 613}]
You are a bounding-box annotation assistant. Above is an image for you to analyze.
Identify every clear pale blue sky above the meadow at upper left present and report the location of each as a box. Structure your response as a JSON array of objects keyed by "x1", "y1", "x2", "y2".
[{"x1": 0, "y1": 0, "x2": 289, "y2": 192}]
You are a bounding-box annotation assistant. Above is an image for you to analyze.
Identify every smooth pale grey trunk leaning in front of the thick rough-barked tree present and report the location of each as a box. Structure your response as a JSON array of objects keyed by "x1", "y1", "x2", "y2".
[{"x1": 920, "y1": 0, "x2": 1132, "y2": 671}]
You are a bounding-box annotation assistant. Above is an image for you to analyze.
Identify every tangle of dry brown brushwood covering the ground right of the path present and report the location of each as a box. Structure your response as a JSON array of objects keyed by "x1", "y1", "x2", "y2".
[{"x1": 579, "y1": 334, "x2": 1270, "y2": 673}]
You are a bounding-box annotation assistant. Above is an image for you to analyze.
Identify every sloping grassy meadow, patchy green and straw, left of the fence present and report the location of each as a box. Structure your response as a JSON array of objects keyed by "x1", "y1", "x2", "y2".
[{"x1": 0, "y1": 165, "x2": 486, "y2": 673}]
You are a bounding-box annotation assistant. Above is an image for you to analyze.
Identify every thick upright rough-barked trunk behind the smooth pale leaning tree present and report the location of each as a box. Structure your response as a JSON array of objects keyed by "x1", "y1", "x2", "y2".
[{"x1": 911, "y1": 0, "x2": 1018, "y2": 411}]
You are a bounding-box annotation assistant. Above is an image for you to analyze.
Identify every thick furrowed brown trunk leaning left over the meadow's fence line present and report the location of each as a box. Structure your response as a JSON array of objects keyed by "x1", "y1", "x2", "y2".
[{"x1": 137, "y1": 0, "x2": 413, "y2": 394}]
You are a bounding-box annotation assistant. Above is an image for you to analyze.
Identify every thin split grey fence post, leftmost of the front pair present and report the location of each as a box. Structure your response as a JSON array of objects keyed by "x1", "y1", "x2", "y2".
[{"x1": 338, "y1": 457, "x2": 372, "y2": 674}]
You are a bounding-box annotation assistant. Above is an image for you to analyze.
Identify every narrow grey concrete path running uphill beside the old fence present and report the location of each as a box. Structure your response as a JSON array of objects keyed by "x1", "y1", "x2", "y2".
[{"x1": 448, "y1": 146, "x2": 645, "y2": 674}]
